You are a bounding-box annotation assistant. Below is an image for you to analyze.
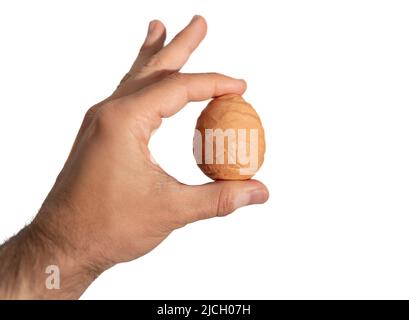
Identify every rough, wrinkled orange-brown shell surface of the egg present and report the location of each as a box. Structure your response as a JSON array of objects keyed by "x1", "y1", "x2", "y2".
[{"x1": 194, "y1": 94, "x2": 265, "y2": 180}]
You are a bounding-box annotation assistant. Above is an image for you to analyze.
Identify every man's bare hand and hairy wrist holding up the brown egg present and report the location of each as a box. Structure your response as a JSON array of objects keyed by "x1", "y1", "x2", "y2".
[{"x1": 0, "y1": 16, "x2": 268, "y2": 299}]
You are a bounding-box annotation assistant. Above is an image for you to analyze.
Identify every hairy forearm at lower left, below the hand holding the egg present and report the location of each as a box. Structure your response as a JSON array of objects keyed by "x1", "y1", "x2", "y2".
[{"x1": 0, "y1": 212, "x2": 98, "y2": 299}]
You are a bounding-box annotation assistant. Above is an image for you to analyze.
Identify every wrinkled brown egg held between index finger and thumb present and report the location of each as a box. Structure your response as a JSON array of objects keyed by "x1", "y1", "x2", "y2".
[{"x1": 193, "y1": 94, "x2": 265, "y2": 180}]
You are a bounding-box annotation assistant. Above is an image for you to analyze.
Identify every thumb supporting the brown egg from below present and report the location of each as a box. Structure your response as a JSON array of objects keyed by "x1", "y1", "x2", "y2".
[{"x1": 178, "y1": 180, "x2": 269, "y2": 223}]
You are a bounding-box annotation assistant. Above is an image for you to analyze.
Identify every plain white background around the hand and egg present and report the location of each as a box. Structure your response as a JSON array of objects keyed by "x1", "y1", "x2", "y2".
[{"x1": 0, "y1": 0, "x2": 409, "y2": 299}]
